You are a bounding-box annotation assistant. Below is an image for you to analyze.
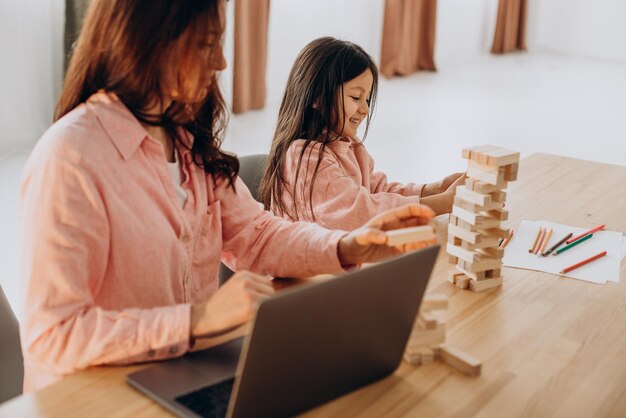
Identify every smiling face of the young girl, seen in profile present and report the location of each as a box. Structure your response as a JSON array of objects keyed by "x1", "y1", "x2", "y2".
[{"x1": 334, "y1": 69, "x2": 374, "y2": 137}]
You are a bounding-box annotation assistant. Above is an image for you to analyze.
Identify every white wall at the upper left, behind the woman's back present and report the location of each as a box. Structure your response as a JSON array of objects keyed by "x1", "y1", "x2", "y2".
[{"x1": 0, "y1": 0, "x2": 65, "y2": 149}]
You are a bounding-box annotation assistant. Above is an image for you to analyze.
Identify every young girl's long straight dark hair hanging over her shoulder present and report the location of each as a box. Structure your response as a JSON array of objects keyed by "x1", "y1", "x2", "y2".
[{"x1": 259, "y1": 37, "x2": 378, "y2": 220}]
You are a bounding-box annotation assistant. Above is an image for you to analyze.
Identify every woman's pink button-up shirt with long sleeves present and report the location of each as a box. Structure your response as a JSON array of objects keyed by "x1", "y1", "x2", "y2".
[{"x1": 21, "y1": 92, "x2": 345, "y2": 391}]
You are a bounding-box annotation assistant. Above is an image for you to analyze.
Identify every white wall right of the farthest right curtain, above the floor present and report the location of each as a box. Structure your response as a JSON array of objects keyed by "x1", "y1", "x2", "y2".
[{"x1": 529, "y1": 0, "x2": 626, "y2": 62}]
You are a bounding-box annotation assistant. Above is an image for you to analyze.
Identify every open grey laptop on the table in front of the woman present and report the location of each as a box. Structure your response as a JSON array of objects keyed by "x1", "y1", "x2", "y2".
[{"x1": 127, "y1": 246, "x2": 439, "y2": 417}]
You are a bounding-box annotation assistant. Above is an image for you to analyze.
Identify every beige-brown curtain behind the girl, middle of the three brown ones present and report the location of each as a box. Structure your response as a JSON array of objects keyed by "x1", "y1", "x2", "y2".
[{"x1": 380, "y1": 0, "x2": 437, "y2": 77}]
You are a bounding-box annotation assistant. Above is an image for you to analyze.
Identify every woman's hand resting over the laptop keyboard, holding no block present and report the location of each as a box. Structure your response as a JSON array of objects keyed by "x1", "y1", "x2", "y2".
[{"x1": 191, "y1": 271, "x2": 274, "y2": 338}]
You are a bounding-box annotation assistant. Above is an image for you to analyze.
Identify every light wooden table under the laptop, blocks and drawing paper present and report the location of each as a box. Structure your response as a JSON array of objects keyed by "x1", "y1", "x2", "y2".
[{"x1": 0, "y1": 154, "x2": 626, "y2": 417}]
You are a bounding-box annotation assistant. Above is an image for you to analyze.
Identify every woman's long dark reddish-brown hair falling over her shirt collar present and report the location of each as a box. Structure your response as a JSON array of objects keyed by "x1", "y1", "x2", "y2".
[{"x1": 55, "y1": 0, "x2": 239, "y2": 187}]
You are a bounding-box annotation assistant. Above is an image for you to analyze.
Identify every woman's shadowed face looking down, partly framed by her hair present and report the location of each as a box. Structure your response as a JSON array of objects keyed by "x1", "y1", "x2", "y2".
[{"x1": 164, "y1": 0, "x2": 226, "y2": 104}]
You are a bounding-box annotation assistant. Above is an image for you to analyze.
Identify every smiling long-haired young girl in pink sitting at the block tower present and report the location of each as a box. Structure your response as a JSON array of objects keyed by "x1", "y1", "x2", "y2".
[{"x1": 260, "y1": 37, "x2": 463, "y2": 229}]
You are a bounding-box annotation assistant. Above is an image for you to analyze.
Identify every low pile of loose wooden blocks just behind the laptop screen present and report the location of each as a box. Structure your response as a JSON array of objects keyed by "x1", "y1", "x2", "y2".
[{"x1": 404, "y1": 295, "x2": 481, "y2": 376}]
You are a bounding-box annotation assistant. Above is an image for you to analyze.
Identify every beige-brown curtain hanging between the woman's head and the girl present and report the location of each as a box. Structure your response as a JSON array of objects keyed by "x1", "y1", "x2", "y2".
[{"x1": 233, "y1": 0, "x2": 270, "y2": 113}]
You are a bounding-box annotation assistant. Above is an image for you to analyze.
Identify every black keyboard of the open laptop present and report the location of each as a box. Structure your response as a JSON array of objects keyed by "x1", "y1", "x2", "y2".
[{"x1": 176, "y1": 378, "x2": 235, "y2": 418}]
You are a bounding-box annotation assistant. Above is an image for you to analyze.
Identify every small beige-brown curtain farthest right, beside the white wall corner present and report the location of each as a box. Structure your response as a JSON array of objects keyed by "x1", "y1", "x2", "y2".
[{"x1": 491, "y1": 0, "x2": 526, "y2": 54}]
